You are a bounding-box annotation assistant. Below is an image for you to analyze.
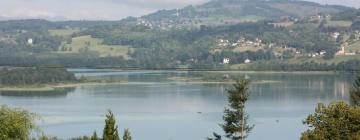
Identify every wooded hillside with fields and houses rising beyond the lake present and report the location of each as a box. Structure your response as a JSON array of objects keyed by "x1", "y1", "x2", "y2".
[{"x1": 0, "y1": 0, "x2": 360, "y2": 70}]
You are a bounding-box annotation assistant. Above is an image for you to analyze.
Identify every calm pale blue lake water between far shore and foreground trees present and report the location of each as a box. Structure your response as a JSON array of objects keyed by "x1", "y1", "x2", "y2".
[{"x1": 0, "y1": 70, "x2": 353, "y2": 140}]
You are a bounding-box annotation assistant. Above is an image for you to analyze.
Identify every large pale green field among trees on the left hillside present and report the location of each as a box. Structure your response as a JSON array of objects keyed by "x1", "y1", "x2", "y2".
[{"x1": 58, "y1": 35, "x2": 132, "y2": 59}]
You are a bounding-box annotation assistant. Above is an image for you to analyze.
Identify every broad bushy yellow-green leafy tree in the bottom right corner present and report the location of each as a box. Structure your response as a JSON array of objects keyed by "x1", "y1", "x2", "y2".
[{"x1": 301, "y1": 102, "x2": 360, "y2": 140}]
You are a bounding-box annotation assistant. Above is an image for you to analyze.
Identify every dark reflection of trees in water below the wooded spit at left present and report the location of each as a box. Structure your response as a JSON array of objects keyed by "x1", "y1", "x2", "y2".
[{"x1": 0, "y1": 87, "x2": 75, "y2": 98}]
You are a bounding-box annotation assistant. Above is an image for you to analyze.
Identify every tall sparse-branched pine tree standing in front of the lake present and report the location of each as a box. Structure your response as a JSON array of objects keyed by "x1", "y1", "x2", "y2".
[{"x1": 221, "y1": 80, "x2": 254, "y2": 140}]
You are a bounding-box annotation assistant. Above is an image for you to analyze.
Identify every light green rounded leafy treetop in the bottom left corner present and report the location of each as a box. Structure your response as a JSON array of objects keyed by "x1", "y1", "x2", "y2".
[{"x1": 0, "y1": 106, "x2": 36, "y2": 140}]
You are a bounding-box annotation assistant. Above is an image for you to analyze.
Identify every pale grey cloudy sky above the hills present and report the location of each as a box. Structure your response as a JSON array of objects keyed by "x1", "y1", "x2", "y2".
[{"x1": 0, "y1": 0, "x2": 360, "y2": 20}]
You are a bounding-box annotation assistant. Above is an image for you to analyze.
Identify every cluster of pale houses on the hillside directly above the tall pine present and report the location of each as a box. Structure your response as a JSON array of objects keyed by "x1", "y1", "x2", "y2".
[{"x1": 217, "y1": 37, "x2": 263, "y2": 47}]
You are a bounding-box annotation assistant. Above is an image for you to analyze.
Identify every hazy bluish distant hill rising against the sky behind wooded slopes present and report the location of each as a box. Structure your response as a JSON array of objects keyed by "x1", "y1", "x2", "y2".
[{"x1": 140, "y1": 0, "x2": 351, "y2": 25}]
